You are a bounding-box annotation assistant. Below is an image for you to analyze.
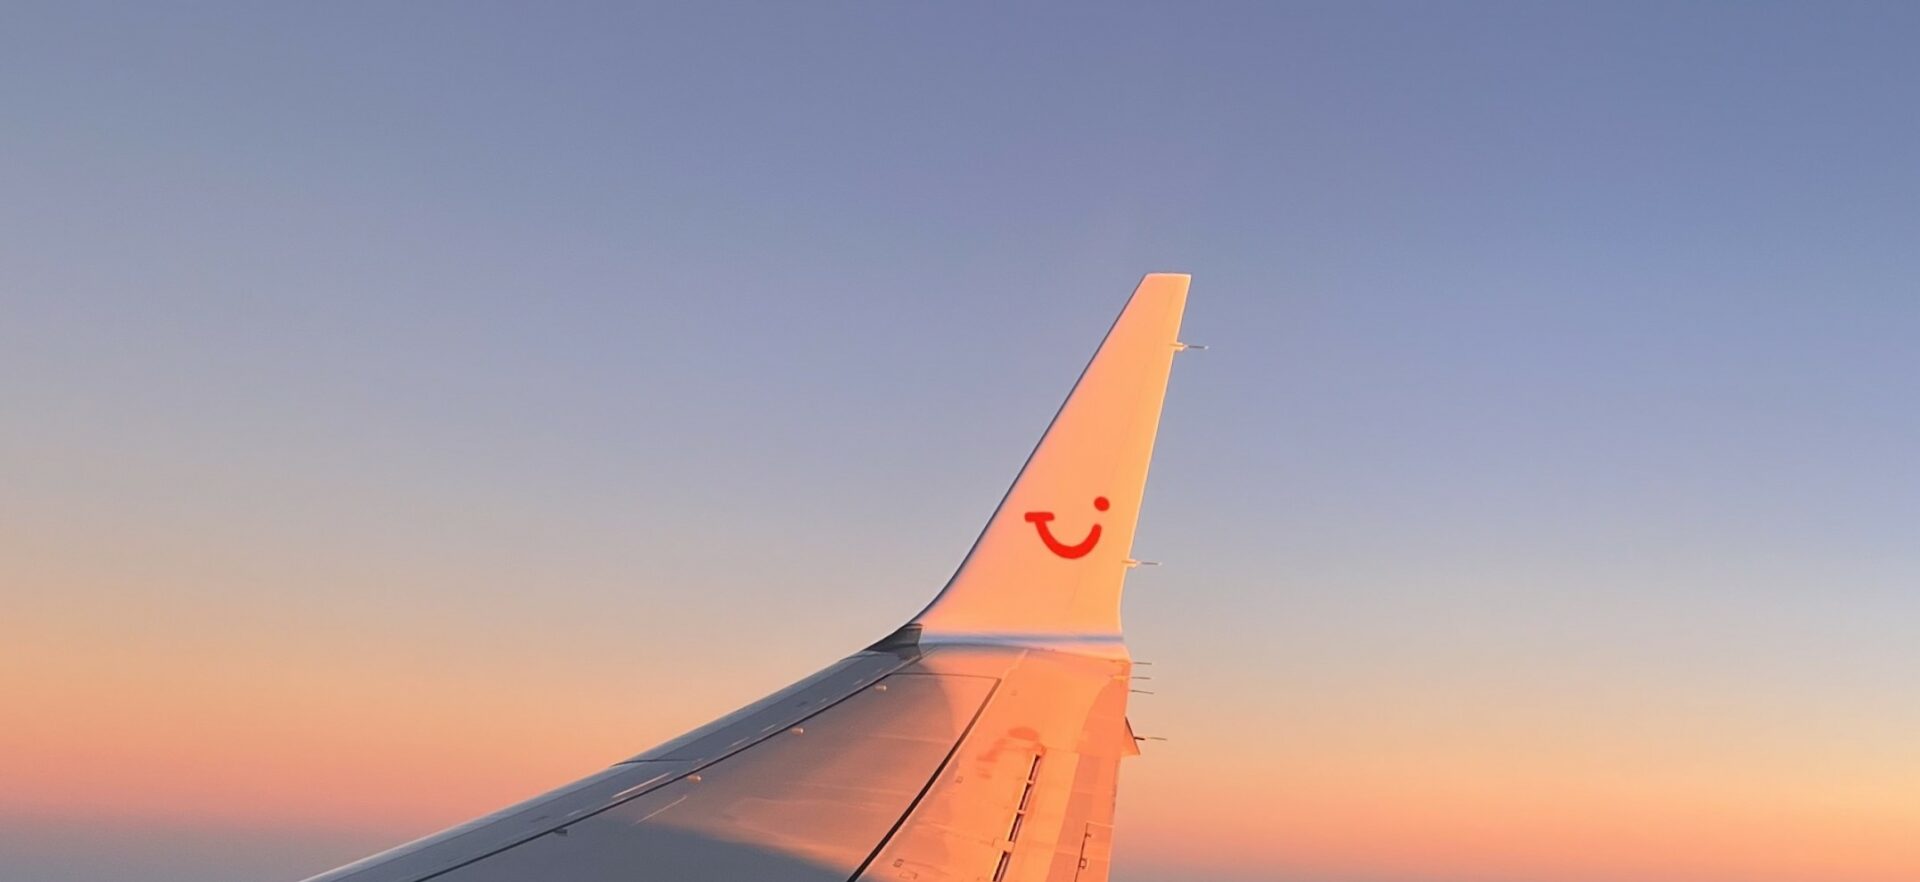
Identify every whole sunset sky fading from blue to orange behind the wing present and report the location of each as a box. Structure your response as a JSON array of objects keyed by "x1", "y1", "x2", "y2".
[{"x1": 0, "y1": 2, "x2": 1920, "y2": 882}]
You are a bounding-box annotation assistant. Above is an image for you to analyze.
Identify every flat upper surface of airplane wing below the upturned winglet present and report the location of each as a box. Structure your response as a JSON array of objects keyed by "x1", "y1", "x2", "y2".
[{"x1": 311, "y1": 646, "x2": 1133, "y2": 882}]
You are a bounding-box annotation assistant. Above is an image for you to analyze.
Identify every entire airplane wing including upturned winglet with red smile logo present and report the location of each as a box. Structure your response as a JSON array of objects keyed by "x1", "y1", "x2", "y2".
[{"x1": 307, "y1": 273, "x2": 1188, "y2": 882}]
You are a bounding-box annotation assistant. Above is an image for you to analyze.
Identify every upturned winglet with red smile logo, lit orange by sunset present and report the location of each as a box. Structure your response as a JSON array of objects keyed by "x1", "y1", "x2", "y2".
[{"x1": 906, "y1": 273, "x2": 1188, "y2": 644}]
